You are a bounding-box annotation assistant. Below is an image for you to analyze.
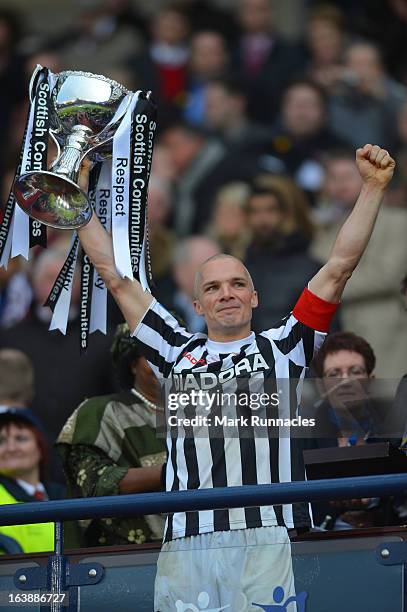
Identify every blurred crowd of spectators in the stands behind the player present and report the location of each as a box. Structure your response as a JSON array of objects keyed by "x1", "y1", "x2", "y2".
[{"x1": 0, "y1": 0, "x2": 407, "y2": 544}]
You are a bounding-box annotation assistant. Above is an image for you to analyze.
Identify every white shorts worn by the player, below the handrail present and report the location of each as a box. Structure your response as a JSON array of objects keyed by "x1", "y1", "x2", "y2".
[{"x1": 154, "y1": 527, "x2": 297, "y2": 612}]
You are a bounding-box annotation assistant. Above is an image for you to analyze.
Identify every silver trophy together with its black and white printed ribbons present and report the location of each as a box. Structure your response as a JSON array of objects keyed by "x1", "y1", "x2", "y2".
[{"x1": 0, "y1": 67, "x2": 156, "y2": 352}]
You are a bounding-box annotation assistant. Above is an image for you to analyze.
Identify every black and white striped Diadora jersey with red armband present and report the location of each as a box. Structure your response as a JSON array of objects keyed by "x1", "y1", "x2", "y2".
[{"x1": 133, "y1": 289, "x2": 336, "y2": 540}]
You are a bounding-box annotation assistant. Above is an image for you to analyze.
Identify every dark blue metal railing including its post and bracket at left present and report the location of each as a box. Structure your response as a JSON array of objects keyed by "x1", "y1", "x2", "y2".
[{"x1": 0, "y1": 474, "x2": 407, "y2": 612}]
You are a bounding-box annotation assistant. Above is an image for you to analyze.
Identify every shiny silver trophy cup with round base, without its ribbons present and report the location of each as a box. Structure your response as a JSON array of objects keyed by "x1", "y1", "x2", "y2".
[{"x1": 13, "y1": 71, "x2": 130, "y2": 229}]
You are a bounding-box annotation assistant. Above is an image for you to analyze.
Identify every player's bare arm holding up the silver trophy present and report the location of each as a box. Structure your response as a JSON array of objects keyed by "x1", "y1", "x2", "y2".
[{"x1": 78, "y1": 163, "x2": 153, "y2": 330}]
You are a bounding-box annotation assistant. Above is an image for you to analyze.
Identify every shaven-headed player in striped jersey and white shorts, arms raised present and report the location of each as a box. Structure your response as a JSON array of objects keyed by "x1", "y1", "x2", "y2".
[{"x1": 79, "y1": 145, "x2": 395, "y2": 612}]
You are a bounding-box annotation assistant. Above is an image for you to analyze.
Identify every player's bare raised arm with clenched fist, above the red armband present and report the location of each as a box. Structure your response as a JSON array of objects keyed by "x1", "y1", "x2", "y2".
[{"x1": 309, "y1": 144, "x2": 396, "y2": 302}]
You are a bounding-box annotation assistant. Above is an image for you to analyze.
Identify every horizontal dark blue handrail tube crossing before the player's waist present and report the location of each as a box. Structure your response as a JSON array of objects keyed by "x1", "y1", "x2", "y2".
[{"x1": 0, "y1": 474, "x2": 407, "y2": 525}]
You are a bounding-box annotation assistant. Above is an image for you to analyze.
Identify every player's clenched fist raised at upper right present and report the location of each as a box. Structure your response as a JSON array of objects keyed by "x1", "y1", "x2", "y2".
[{"x1": 356, "y1": 144, "x2": 396, "y2": 189}]
